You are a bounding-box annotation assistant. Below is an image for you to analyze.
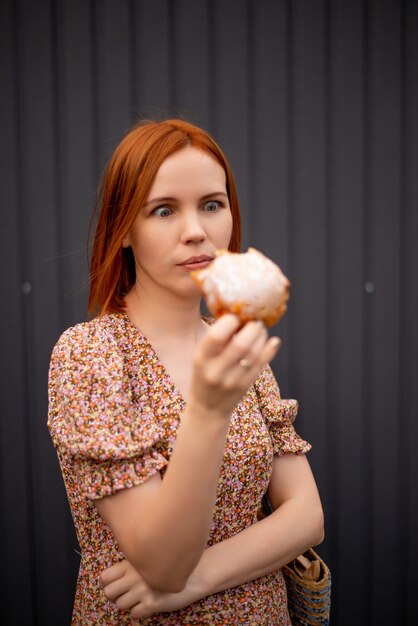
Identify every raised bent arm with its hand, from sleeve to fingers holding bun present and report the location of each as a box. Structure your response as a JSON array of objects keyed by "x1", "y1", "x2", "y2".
[{"x1": 95, "y1": 315, "x2": 278, "y2": 592}]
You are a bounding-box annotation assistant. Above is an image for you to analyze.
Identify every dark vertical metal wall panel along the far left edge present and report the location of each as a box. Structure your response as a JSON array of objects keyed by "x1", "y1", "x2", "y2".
[{"x1": 0, "y1": 1, "x2": 37, "y2": 624}]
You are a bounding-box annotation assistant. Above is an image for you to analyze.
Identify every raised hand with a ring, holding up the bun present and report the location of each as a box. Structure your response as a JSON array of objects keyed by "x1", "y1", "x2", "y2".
[{"x1": 189, "y1": 314, "x2": 280, "y2": 417}]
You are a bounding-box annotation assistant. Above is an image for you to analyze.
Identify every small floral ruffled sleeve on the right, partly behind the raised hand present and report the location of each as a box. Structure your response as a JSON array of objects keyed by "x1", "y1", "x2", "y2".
[{"x1": 254, "y1": 365, "x2": 312, "y2": 455}]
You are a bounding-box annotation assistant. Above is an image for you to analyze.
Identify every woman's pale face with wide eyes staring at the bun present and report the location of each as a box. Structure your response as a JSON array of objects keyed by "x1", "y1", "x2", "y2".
[{"x1": 123, "y1": 146, "x2": 232, "y2": 297}]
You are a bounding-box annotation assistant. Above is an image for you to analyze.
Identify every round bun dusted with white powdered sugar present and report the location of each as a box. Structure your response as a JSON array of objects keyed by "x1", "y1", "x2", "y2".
[{"x1": 191, "y1": 248, "x2": 290, "y2": 327}]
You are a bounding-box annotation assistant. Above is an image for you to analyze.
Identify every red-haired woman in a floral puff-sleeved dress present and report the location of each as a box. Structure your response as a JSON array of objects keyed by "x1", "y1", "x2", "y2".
[{"x1": 48, "y1": 120, "x2": 323, "y2": 626}]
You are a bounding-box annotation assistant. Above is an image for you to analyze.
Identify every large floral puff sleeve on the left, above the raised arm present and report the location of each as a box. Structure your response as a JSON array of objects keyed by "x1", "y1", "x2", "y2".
[{"x1": 48, "y1": 322, "x2": 167, "y2": 499}]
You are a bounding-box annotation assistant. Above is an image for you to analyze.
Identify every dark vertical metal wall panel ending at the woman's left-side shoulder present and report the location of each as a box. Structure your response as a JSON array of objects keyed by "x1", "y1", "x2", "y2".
[{"x1": 51, "y1": 0, "x2": 99, "y2": 326}]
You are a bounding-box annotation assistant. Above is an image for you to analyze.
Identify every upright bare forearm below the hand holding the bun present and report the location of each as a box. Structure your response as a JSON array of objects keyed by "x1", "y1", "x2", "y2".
[{"x1": 138, "y1": 407, "x2": 229, "y2": 583}]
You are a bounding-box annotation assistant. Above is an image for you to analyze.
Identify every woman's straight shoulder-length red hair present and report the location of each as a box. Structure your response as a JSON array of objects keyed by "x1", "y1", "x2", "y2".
[{"x1": 88, "y1": 119, "x2": 241, "y2": 314}]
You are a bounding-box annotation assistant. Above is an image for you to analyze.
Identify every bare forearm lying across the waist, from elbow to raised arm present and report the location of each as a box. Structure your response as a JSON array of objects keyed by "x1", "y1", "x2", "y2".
[{"x1": 192, "y1": 498, "x2": 323, "y2": 597}]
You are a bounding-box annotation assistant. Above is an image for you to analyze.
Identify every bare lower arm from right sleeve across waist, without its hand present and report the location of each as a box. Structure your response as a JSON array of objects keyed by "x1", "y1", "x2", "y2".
[{"x1": 194, "y1": 454, "x2": 324, "y2": 594}]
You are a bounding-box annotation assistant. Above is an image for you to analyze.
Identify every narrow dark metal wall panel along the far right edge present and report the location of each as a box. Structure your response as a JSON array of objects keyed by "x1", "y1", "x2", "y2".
[{"x1": 399, "y1": 0, "x2": 418, "y2": 624}]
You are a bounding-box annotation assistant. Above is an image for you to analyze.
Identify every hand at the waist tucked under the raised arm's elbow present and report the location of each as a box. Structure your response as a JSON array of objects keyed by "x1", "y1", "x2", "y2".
[{"x1": 100, "y1": 559, "x2": 203, "y2": 618}]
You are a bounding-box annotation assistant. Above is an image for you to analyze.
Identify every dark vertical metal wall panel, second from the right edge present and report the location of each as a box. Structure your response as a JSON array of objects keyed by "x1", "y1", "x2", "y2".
[{"x1": 366, "y1": 1, "x2": 401, "y2": 624}]
